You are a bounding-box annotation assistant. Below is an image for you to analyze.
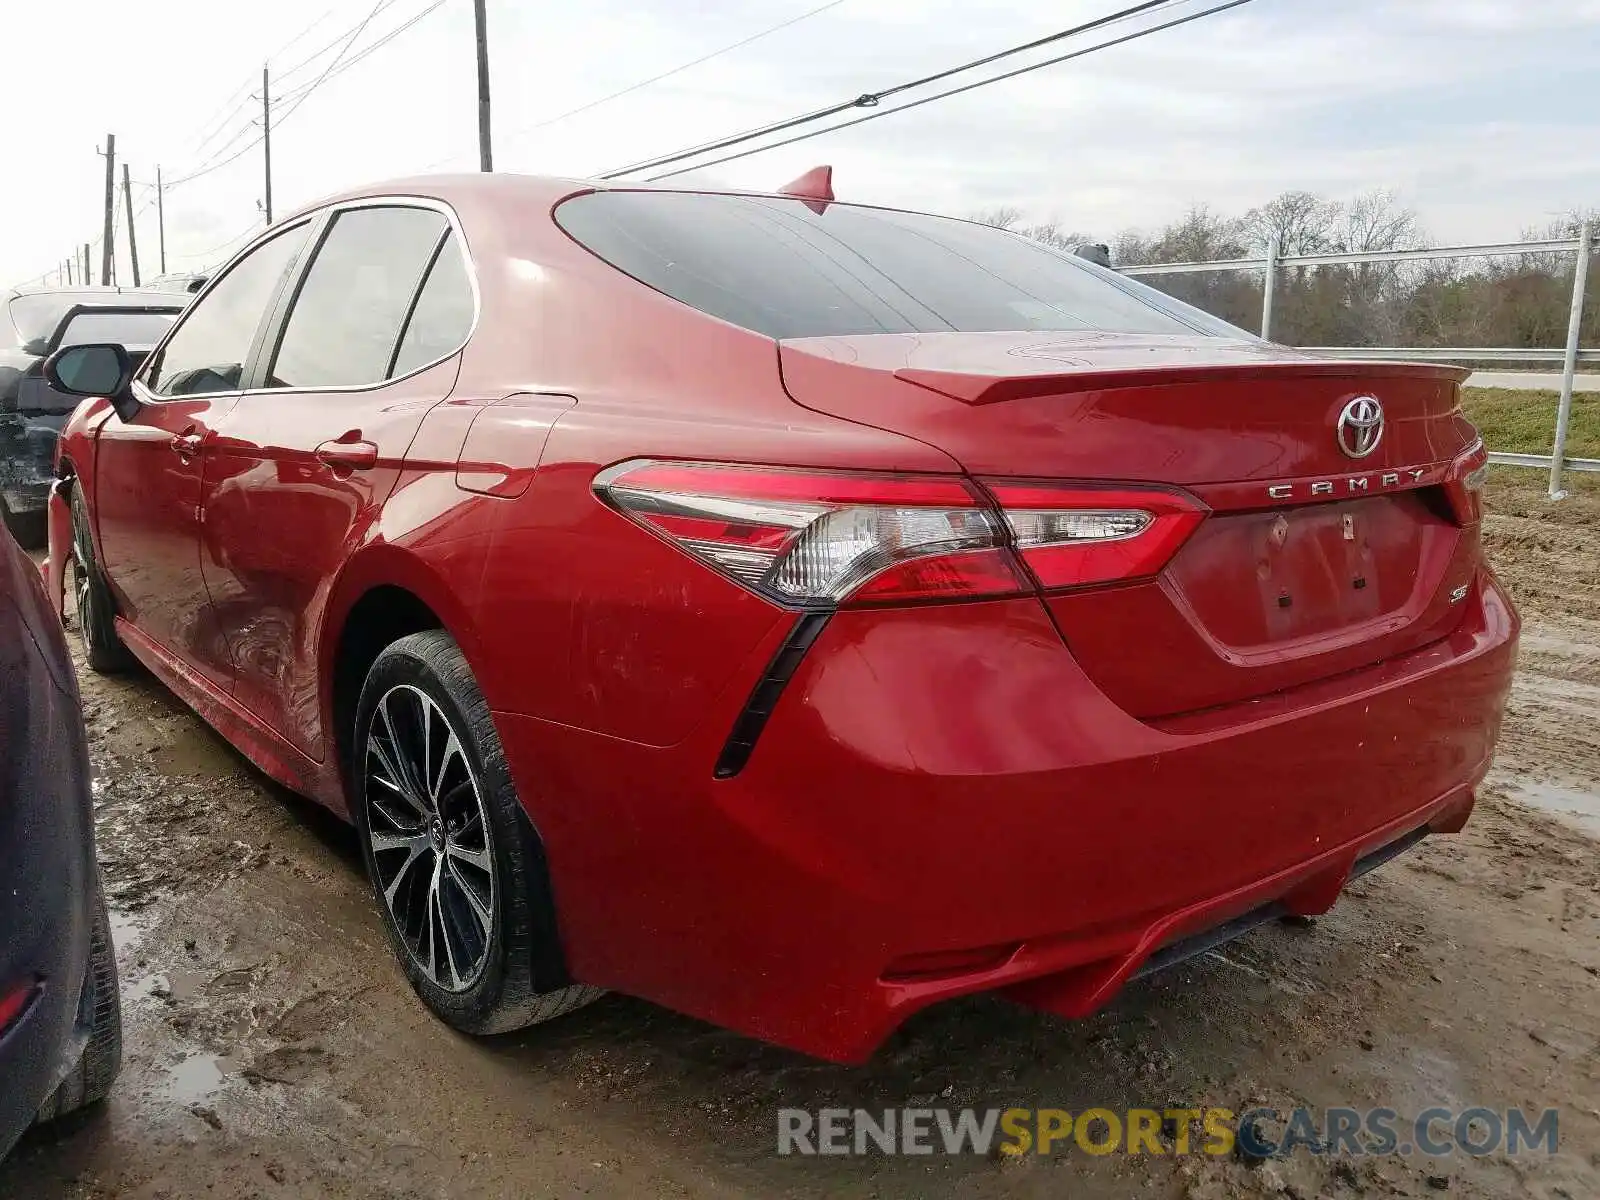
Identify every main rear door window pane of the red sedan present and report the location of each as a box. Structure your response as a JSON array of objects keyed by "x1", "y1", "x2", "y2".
[{"x1": 264, "y1": 205, "x2": 459, "y2": 387}]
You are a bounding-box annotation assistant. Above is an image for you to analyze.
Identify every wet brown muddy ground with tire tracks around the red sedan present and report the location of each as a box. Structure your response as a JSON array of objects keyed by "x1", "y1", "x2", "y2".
[{"x1": 0, "y1": 469, "x2": 1600, "y2": 1200}]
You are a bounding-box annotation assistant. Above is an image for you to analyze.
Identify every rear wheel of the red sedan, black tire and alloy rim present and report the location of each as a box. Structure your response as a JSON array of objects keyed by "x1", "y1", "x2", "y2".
[{"x1": 350, "y1": 629, "x2": 602, "y2": 1034}]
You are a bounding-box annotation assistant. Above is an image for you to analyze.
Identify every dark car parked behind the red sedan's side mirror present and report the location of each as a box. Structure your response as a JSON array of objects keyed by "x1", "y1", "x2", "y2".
[{"x1": 0, "y1": 288, "x2": 189, "y2": 547}]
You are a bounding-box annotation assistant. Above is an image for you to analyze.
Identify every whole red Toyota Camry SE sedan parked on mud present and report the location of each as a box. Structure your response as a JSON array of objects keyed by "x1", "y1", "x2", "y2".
[{"x1": 34, "y1": 176, "x2": 1518, "y2": 1061}]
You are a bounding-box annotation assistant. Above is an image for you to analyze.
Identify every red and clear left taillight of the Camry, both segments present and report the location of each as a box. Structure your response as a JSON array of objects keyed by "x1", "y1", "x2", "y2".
[{"x1": 595, "y1": 459, "x2": 1206, "y2": 608}]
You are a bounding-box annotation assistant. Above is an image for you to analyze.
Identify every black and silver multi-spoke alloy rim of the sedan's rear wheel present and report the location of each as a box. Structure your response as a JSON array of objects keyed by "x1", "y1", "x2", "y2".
[{"x1": 362, "y1": 683, "x2": 496, "y2": 992}]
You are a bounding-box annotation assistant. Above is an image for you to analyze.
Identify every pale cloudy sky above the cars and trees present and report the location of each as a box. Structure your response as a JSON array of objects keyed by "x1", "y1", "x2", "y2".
[{"x1": 0, "y1": 0, "x2": 1600, "y2": 283}]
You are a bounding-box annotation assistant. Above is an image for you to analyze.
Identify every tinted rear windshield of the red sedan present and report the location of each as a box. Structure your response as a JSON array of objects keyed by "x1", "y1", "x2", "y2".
[{"x1": 555, "y1": 192, "x2": 1251, "y2": 338}]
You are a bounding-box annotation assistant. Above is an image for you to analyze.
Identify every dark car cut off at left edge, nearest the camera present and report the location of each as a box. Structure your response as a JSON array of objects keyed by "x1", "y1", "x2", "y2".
[{"x1": 0, "y1": 531, "x2": 122, "y2": 1157}]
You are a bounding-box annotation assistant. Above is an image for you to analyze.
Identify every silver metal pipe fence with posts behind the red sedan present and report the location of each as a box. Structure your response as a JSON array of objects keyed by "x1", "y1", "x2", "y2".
[{"x1": 1120, "y1": 226, "x2": 1600, "y2": 499}]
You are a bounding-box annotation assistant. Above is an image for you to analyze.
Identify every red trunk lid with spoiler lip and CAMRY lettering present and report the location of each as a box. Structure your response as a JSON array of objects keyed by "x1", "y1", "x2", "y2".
[{"x1": 779, "y1": 333, "x2": 1478, "y2": 720}]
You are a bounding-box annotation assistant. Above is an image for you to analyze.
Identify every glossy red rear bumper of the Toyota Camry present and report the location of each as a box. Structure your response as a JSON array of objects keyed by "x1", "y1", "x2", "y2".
[{"x1": 496, "y1": 574, "x2": 1518, "y2": 1061}]
